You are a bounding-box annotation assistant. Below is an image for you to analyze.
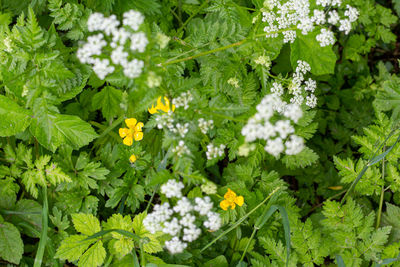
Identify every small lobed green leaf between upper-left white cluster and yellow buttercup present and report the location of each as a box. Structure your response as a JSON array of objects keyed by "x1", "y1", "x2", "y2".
[{"x1": 92, "y1": 86, "x2": 122, "y2": 121}]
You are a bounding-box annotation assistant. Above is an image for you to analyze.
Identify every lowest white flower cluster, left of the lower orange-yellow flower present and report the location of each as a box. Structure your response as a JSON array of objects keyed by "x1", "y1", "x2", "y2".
[{"x1": 143, "y1": 180, "x2": 222, "y2": 254}]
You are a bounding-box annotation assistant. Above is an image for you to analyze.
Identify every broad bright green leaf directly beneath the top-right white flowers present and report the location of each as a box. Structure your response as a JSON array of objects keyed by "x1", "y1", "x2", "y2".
[{"x1": 290, "y1": 30, "x2": 336, "y2": 75}]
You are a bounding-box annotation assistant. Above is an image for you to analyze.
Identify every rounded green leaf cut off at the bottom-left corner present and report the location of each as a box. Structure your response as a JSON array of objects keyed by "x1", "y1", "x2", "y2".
[{"x1": 0, "y1": 222, "x2": 24, "y2": 264}]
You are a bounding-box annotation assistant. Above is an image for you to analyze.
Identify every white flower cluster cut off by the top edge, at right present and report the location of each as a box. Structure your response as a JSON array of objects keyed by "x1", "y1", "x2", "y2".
[{"x1": 262, "y1": 0, "x2": 359, "y2": 47}]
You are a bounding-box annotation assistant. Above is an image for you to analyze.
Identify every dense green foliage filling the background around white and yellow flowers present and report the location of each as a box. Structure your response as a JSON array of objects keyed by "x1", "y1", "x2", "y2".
[{"x1": 0, "y1": 0, "x2": 400, "y2": 267}]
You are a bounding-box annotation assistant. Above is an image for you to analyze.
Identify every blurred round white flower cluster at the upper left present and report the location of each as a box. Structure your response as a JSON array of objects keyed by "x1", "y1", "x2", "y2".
[{"x1": 77, "y1": 10, "x2": 148, "y2": 80}]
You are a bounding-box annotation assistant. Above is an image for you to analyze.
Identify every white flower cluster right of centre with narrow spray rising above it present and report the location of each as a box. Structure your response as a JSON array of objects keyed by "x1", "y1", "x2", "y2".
[{"x1": 242, "y1": 61, "x2": 317, "y2": 157}]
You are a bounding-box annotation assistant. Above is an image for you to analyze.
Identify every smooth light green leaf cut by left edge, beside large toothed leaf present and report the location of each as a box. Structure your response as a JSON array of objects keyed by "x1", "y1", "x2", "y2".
[{"x1": 0, "y1": 95, "x2": 32, "y2": 137}]
